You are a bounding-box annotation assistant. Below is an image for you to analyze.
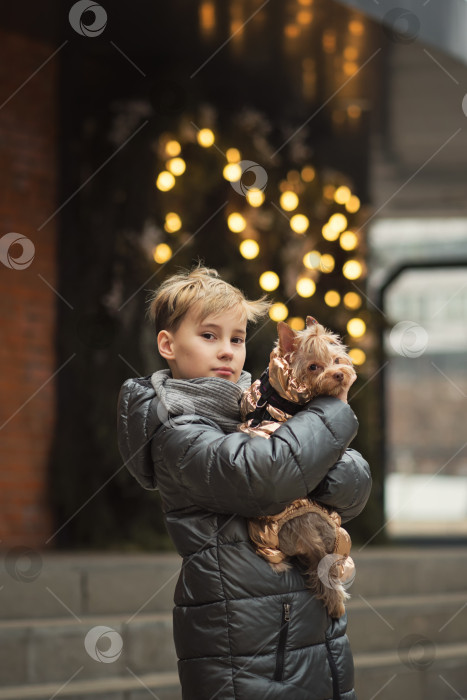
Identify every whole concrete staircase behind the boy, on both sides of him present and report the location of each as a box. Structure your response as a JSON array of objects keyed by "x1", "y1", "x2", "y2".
[{"x1": 0, "y1": 546, "x2": 467, "y2": 700}]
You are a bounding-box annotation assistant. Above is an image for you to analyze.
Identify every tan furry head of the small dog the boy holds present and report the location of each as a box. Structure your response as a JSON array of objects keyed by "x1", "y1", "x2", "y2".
[{"x1": 274, "y1": 316, "x2": 355, "y2": 396}]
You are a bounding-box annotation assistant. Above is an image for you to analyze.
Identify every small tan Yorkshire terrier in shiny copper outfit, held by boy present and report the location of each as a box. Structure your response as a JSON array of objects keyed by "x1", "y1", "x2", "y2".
[{"x1": 239, "y1": 316, "x2": 355, "y2": 617}]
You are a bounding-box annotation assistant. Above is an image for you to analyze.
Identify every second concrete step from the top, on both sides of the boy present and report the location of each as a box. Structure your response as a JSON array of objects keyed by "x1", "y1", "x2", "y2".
[{"x1": 0, "y1": 592, "x2": 467, "y2": 685}]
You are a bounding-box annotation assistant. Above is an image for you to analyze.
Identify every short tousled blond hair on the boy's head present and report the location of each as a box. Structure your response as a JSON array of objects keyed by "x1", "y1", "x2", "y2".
[{"x1": 146, "y1": 263, "x2": 272, "y2": 335}]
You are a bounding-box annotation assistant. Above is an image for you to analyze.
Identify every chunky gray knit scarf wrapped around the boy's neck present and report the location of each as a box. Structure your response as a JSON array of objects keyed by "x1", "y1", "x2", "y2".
[{"x1": 151, "y1": 369, "x2": 251, "y2": 433}]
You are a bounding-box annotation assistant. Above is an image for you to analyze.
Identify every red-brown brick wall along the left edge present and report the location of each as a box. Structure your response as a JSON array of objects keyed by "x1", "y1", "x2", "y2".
[{"x1": 0, "y1": 31, "x2": 59, "y2": 548}]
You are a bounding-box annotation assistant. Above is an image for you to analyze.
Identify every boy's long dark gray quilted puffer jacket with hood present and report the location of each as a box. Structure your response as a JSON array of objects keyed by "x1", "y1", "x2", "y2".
[{"x1": 118, "y1": 376, "x2": 371, "y2": 700}]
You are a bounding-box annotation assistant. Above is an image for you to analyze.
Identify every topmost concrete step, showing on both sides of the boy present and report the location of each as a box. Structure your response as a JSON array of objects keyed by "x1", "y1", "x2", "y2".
[{"x1": 0, "y1": 547, "x2": 467, "y2": 619}]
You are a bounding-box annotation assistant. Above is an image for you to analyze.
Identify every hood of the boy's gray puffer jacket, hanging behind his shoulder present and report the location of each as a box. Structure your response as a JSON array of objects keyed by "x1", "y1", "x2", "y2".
[{"x1": 117, "y1": 375, "x2": 162, "y2": 490}]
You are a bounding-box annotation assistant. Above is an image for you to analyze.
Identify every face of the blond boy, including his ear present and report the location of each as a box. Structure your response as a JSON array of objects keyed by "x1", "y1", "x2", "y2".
[{"x1": 157, "y1": 306, "x2": 246, "y2": 383}]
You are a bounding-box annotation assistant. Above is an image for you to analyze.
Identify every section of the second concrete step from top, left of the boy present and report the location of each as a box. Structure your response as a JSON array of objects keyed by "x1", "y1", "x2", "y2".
[{"x1": 0, "y1": 613, "x2": 177, "y2": 686}]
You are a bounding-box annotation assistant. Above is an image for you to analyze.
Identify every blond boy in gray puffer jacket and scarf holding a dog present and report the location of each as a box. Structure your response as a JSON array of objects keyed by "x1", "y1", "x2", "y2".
[{"x1": 118, "y1": 266, "x2": 371, "y2": 700}]
